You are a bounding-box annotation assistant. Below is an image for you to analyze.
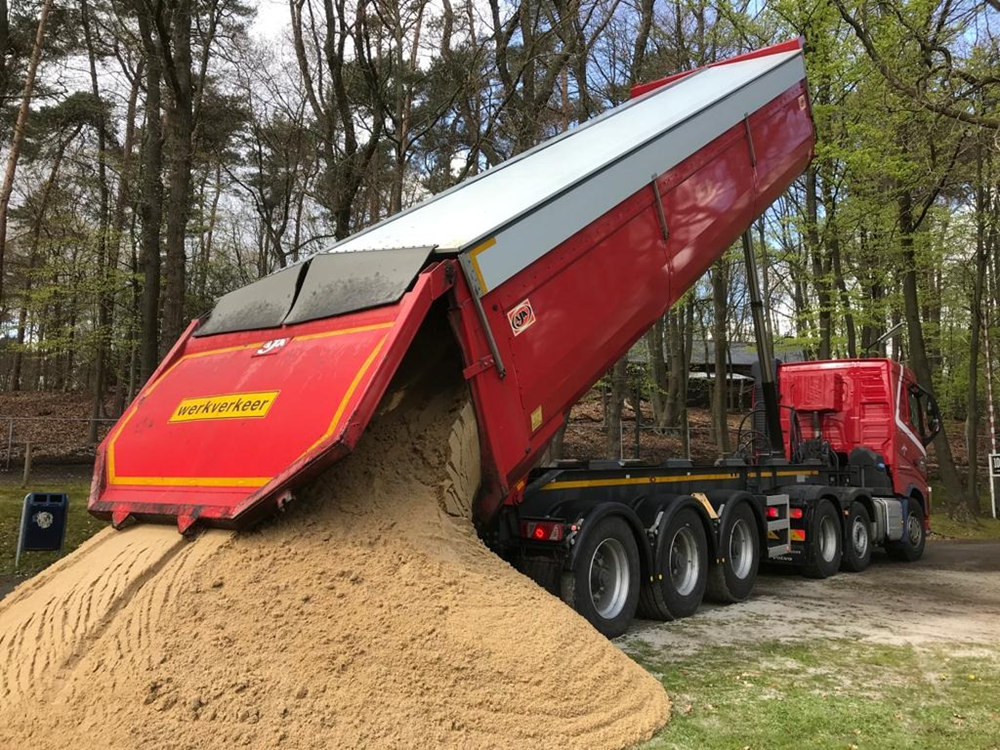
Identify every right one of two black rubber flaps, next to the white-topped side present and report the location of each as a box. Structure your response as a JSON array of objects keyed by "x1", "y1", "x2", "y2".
[{"x1": 285, "y1": 247, "x2": 434, "y2": 323}]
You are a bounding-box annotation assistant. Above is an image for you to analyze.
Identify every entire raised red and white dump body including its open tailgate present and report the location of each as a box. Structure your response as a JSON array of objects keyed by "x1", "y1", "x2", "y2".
[{"x1": 90, "y1": 41, "x2": 814, "y2": 530}]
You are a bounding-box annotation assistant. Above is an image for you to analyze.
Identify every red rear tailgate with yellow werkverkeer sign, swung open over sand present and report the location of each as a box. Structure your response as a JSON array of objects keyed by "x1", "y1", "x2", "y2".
[{"x1": 89, "y1": 266, "x2": 452, "y2": 531}]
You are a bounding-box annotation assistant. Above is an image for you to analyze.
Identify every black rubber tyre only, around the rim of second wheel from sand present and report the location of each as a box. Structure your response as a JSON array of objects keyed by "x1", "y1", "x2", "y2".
[{"x1": 639, "y1": 507, "x2": 708, "y2": 620}]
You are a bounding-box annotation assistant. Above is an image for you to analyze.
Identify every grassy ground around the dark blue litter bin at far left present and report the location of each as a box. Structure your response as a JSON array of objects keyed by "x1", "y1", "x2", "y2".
[{"x1": 0, "y1": 477, "x2": 106, "y2": 578}]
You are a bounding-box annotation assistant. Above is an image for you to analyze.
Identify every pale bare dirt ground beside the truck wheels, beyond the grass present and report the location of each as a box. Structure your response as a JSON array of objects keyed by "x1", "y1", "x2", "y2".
[{"x1": 620, "y1": 541, "x2": 1000, "y2": 655}]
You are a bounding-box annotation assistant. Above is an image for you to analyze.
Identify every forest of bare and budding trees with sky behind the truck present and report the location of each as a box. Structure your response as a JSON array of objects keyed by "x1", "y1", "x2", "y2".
[{"x1": 0, "y1": 0, "x2": 1000, "y2": 518}]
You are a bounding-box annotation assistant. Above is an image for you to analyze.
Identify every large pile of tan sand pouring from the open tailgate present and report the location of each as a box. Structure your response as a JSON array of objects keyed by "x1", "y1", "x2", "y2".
[{"x1": 0, "y1": 368, "x2": 669, "y2": 750}]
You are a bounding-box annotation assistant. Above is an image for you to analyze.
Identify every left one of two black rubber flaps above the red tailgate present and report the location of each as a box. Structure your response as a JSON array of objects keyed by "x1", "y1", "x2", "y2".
[{"x1": 194, "y1": 263, "x2": 308, "y2": 336}]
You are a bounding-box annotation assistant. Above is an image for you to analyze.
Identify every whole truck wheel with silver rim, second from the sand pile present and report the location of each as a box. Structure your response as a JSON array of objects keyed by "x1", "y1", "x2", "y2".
[{"x1": 639, "y1": 508, "x2": 708, "y2": 620}]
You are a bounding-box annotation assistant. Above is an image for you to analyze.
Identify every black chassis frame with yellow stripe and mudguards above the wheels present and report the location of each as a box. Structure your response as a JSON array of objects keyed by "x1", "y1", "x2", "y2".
[{"x1": 496, "y1": 460, "x2": 905, "y2": 595}]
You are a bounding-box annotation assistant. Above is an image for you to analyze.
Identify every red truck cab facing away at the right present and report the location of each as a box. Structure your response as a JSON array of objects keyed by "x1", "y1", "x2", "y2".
[{"x1": 778, "y1": 359, "x2": 940, "y2": 523}]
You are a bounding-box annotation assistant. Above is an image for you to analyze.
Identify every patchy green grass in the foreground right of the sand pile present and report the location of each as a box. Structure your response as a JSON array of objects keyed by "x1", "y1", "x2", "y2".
[{"x1": 630, "y1": 641, "x2": 1000, "y2": 750}]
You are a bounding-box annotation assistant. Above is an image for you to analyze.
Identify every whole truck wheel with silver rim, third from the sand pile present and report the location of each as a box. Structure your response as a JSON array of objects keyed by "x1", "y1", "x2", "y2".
[{"x1": 707, "y1": 502, "x2": 760, "y2": 604}]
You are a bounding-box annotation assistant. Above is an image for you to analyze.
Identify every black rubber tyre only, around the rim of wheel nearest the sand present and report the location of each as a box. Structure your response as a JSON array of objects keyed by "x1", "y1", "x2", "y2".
[{"x1": 560, "y1": 516, "x2": 642, "y2": 638}]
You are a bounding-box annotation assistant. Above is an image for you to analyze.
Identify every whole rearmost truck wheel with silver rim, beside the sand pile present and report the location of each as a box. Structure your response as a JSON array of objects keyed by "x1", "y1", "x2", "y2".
[{"x1": 561, "y1": 516, "x2": 640, "y2": 638}]
